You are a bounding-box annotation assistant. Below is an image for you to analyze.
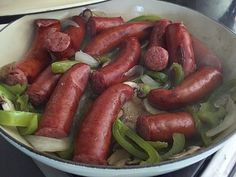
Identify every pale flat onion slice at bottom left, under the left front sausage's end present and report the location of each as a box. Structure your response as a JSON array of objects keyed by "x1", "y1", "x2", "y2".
[{"x1": 25, "y1": 135, "x2": 71, "y2": 152}]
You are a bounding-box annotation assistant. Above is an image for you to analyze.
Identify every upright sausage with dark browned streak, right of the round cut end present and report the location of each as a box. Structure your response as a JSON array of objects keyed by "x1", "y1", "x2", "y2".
[{"x1": 166, "y1": 23, "x2": 196, "y2": 76}]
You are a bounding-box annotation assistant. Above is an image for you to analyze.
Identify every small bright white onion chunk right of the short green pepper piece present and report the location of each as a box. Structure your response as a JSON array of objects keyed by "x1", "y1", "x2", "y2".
[{"x1": 75, "y1": 50, "x2": 99, "y2": 68}]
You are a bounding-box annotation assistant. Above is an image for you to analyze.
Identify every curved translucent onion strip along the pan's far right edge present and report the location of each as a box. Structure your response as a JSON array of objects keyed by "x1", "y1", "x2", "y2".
[{"x1": 206, "y1": 97, "x2": 236, "y2": 137}]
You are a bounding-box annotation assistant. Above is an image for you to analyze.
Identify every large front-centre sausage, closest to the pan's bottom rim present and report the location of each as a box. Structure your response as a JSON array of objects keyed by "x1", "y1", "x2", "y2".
[{"x1": 74, "y1": 84, "x2": 134, "y2": 165}]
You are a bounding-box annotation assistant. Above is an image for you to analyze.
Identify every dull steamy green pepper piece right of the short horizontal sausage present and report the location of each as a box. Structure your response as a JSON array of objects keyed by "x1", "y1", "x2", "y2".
[{"x1": 198, "y1": 101, "x2": 226, "y2": 127}]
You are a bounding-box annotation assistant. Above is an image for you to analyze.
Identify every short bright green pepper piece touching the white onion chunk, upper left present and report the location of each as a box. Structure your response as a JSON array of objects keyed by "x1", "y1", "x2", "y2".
[{"x1": 51, "y1": 60, "x2": 80, "y2": 73}]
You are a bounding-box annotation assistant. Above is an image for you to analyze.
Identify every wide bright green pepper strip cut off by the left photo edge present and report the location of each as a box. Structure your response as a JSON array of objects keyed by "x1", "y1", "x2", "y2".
[{"x1": 0, "y1": 110, "x2": 39, "y2": 134}]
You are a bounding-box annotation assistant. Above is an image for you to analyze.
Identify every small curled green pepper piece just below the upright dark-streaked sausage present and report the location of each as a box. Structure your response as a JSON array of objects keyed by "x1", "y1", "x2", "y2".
[{"x1": 170, "y1": 63, "x2": 184, "y2": 86}]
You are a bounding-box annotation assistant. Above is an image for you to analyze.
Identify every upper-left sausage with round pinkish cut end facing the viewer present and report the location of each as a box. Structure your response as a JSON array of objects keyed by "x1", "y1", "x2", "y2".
[{"x1": 47, "y1": 16, "x2": 86, "y2": 60}]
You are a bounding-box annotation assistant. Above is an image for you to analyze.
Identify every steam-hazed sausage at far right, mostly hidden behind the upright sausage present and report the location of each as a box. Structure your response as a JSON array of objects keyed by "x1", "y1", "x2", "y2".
[{"x1": 191, "y1": 35, "x2": 223, "y2": 72}]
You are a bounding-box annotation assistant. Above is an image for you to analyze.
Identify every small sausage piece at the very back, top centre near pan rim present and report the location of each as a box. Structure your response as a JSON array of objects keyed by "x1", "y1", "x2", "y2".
[{"x1": 87, "y1": 16, "x2": 124, "y2": 36}]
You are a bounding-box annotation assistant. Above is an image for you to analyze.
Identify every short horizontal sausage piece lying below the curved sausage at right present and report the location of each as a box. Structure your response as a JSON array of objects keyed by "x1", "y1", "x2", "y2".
[{"x1": 136, "y1": 112, "x2": 196, "y2": 141}]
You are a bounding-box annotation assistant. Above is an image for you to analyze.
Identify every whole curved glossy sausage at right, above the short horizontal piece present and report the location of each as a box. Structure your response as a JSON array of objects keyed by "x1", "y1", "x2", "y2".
[{"x1": 147, "y1": 67, "x2": 223, "y2": 110}]
